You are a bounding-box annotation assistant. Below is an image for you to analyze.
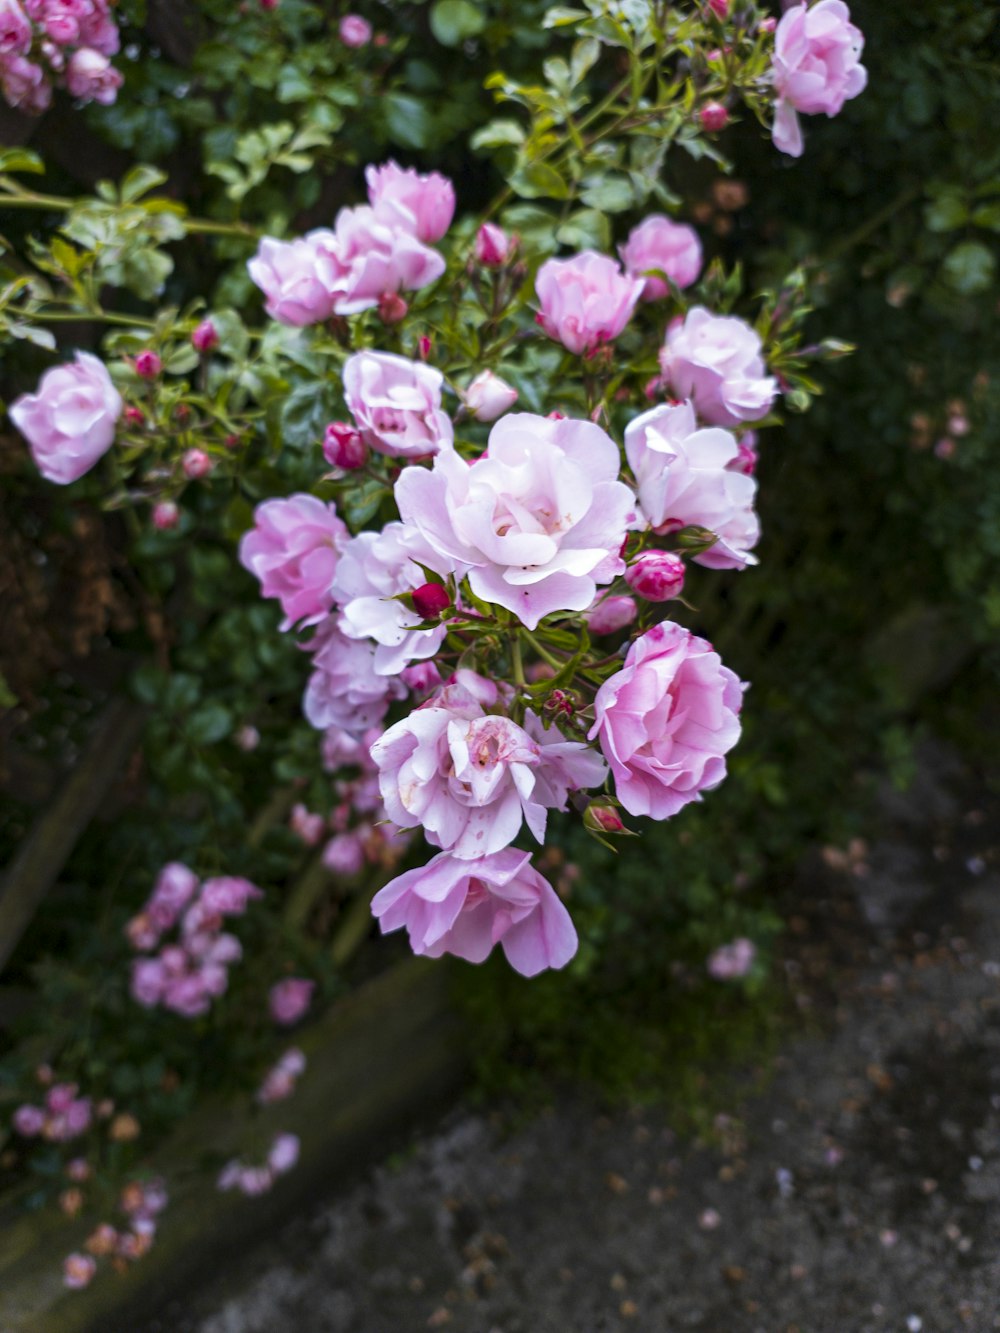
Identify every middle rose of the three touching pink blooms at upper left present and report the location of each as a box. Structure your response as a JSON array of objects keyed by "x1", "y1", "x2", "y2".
[{"x1": 332, "y1": 200, "x2": 447, "y2": 315}]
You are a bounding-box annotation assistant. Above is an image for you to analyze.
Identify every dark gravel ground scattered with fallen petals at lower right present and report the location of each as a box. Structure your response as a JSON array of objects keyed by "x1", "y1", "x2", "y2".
[{"x1": 148, "y1": 750, "x2": 1000, "y2": 1333}]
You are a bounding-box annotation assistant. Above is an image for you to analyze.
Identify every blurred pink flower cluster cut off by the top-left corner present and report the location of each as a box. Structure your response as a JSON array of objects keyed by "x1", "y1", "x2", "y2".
[{"x1": 0, "y1": 0, "x2": 123, "y2": 116}]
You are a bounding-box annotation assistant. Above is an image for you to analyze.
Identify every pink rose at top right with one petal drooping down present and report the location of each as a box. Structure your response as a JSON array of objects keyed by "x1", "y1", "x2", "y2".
[{"x1": 772, "y1": 0, "x2": 868, "y2": 157}]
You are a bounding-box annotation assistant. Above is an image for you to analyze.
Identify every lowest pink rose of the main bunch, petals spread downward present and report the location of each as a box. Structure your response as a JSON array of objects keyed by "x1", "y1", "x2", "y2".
[{"x1": 372, "y1": 848, "x2": 577, "y2": 977}]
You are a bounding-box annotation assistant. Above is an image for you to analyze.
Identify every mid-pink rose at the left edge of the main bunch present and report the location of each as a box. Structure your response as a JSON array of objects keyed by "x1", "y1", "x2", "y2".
[{"x1": 240, "y1": 495, "x2": 348, "y2": 629}]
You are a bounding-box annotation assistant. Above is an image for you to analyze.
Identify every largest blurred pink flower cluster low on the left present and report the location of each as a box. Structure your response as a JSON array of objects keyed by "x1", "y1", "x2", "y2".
[{"x1": 127, "y1": 862, "x2": 261, "y2": 1018}]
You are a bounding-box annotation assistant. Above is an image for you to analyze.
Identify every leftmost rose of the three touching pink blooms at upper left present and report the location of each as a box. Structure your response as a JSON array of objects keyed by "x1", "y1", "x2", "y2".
[{"x1": 247, "y1": 231, "x2": 344, "y2": 328}]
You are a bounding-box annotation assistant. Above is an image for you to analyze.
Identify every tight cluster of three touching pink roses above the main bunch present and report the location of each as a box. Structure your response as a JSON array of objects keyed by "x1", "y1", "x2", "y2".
[{"x1": 247, "y1": 161, "x2": 455, "y2": 325}]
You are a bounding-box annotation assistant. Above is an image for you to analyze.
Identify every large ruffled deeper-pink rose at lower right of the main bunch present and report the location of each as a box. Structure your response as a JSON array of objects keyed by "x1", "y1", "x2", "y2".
[{"x1": 589, "y1": 620, "x2": 743, "y2": 820}]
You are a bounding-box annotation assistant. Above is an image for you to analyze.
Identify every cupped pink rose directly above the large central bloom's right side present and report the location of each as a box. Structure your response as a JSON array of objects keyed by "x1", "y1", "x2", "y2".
[{"x1": 535, "y1": 251, "x2": 645, "y2": 355}]
